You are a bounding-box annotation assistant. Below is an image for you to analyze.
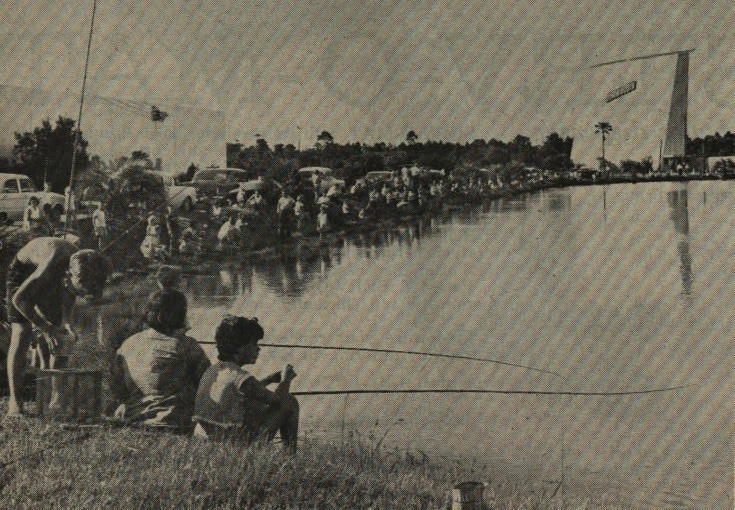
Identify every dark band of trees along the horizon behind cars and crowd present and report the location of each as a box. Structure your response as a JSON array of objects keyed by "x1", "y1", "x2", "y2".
[{"x1": 0, "y1": 116, "x2": 735, "y2": 192}]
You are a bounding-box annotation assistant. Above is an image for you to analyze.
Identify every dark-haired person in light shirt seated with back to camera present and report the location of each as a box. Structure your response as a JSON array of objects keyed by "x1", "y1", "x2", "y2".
[{"x1": 110, "y1": 287, "x2": 209, "y2": 430}]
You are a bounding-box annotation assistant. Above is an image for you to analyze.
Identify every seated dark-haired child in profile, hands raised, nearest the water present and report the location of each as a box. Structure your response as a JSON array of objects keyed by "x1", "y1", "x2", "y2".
[{"x1": 193, "y1": 315, "x2": 299, "y2": 452}]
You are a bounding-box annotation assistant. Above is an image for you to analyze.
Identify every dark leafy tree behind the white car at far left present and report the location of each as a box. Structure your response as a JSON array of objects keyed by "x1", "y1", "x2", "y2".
[{"x1": 13, "y1": 117, "x2": 89, "y2": 191}]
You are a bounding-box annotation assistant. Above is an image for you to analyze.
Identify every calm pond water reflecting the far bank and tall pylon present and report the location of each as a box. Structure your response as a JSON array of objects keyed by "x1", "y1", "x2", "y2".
[{"x1": 99, "y1": 182, "x2": 735, "y2": 508}]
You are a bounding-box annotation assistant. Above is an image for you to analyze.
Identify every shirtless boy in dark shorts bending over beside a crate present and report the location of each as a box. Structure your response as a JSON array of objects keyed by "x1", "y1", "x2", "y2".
[{"x1": 6, "y1": 237, "x2": 109, "y2": 415}]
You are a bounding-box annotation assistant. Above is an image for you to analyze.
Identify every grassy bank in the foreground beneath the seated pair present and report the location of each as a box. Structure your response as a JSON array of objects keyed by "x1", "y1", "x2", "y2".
[{"x1": 0, "y1": 402, "x2": 632, "y2": 510}]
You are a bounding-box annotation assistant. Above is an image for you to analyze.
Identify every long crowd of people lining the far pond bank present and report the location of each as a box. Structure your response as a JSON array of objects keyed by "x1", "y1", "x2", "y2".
[{"x1": 0, "y1": 166, "x2": 732, "y2": 269}]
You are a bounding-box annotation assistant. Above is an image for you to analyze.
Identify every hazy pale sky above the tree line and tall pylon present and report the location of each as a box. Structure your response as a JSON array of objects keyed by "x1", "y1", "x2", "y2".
[{"x1": 0, "y1": 0, "x2": 735, "y2": 170}]
